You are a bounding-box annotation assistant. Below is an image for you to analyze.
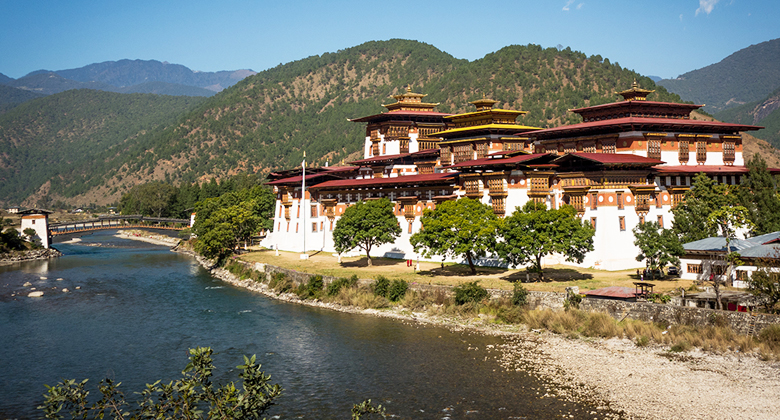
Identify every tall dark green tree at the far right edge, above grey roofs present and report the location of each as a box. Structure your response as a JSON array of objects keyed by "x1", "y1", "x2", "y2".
[{"x1": 737, "y1": 153, "x2": 780, "y2": 235}]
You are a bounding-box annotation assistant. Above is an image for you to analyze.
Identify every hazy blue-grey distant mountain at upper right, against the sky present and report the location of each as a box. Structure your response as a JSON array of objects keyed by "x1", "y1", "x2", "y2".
[{"x1": 658, "y1": 38, "x2": 780, "y2": 114}]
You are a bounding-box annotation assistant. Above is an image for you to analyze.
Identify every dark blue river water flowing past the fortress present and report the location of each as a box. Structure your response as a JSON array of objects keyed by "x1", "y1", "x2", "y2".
[{"x1": 0, "y1": 231, "x2": 608, "y2": 419}]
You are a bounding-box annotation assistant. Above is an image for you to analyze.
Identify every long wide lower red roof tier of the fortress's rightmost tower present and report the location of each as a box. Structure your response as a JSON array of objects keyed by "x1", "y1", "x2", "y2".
[{"x1": 528, "y1": 117, "x2": 764, "y2": 137}]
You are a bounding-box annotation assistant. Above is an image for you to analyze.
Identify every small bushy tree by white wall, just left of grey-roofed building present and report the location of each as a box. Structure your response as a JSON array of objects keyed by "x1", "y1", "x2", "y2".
[{"x1": 634, "y1": 222, "x2": 685, "y2": 276}]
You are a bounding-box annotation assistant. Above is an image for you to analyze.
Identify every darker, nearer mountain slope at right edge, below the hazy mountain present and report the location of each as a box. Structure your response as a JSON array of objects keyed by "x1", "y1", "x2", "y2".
[{"x1": 715, "y1": 88, "x2": 780, "y2": 148}]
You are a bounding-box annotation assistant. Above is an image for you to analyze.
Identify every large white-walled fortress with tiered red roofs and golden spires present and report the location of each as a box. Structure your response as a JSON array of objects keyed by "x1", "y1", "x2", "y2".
[{"x1": 263, "y1": 84, "x2": 761, "y2": 270}]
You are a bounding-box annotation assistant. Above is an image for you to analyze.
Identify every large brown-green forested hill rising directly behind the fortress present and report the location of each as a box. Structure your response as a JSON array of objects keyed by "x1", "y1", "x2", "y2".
[{"x1": 108, "y1": 40, "x2": 679, "y2": 186}]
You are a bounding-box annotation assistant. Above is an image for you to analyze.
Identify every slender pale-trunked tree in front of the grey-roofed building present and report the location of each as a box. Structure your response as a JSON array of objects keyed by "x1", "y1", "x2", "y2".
[{"x1": 707, "y1": 206, "x2": 755, "y2": 309}]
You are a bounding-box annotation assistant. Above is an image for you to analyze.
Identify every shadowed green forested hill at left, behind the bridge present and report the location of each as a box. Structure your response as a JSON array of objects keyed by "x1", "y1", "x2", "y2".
[{"x1": 0, "y1": 89, "x2": 202, "y2": 205}]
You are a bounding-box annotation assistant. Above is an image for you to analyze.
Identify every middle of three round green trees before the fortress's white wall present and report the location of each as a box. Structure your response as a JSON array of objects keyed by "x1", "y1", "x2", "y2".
[{"x1": 409, "y1": 198, "x2": 499, "y2": 274}]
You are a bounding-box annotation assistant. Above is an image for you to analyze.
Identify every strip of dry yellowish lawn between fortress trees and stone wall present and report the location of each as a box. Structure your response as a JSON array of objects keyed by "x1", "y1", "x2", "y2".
[{"x1": 241, "y1": 249, "x2": 692, "y2": 293}]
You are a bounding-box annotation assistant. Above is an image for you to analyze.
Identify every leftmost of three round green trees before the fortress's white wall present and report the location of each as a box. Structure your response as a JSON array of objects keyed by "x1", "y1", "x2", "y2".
[{"x1": 333, "y1": 198, "x2": 401, "y2": 266}]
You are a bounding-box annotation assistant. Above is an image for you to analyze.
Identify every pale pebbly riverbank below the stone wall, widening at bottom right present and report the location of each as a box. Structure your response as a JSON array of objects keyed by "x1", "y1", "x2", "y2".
[{"x1": 116, "y1": 233, "x2": 780, "y2": 419}]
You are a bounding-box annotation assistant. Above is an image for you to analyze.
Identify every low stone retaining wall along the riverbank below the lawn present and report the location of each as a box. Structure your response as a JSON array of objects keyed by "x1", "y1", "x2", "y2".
[{"x1": 237, "y1": 260, "x2": 780, "y2": 334}]
